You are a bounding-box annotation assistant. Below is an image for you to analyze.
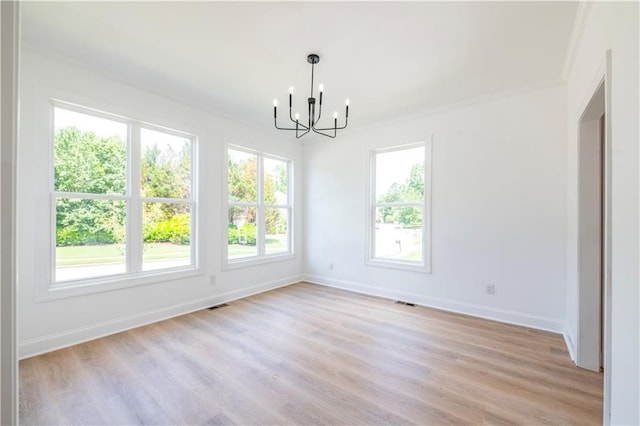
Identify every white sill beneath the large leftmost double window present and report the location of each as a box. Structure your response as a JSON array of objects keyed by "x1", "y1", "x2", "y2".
[{"x1": 35, "y1": 267, "x2": 204, "y2": 303}]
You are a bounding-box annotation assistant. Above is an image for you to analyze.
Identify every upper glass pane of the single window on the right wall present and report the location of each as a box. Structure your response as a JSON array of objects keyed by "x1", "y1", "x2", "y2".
[{"x1": 376, "y1": 147, "x2": 424, "y2": 203}]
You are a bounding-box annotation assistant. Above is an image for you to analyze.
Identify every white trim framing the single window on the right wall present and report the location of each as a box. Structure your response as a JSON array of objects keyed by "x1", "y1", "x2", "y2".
[{"x1": 365, "y1": 135, "x2": 433, "y2": 273}]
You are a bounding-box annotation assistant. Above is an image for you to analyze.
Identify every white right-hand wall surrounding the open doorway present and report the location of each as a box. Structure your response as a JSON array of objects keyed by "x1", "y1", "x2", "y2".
[{"x1": 567, "y1": 2, "x2": 640, "y2": 424}]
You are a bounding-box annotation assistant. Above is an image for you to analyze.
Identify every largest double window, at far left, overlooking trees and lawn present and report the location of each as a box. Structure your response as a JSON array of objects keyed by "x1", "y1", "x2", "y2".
[{"x1": 52, "y1": 102, "x2": 195, "y2": 287}]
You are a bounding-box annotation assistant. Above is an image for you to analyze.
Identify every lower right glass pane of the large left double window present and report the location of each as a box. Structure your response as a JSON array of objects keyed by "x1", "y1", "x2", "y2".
[{"x1": 142, "y1": 203, "x2": 191, "y2": 271}]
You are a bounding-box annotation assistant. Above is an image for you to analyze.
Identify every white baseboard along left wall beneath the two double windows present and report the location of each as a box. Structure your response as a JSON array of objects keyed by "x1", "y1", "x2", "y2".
[{"x1": 18, "y1": 275, "x2": 302, "y2": 359}]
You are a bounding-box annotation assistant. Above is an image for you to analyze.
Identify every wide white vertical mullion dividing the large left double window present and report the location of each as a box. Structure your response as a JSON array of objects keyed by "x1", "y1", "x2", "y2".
[{"x1": 127, "y1": 122, "x2": 142, "y2": 273}]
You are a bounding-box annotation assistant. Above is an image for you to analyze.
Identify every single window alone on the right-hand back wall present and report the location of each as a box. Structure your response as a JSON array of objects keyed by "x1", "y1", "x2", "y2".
[{"x1": 369, "y1": 143, "x2": 430, "y2": 272}]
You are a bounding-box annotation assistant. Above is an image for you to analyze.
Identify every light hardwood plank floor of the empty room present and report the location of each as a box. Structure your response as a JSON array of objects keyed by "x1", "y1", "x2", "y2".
[{"x1": 20, "y1": 283, "x2": 602, "y2": 425}]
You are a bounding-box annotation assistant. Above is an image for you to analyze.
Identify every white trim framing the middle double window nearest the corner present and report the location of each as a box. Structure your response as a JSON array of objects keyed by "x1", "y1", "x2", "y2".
[{"x1": 221, "y1": 143, "x2": 296, "y2": 271}]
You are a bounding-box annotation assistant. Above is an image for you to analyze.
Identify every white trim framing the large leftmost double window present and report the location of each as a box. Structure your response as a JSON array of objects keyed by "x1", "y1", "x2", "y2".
[{"x1": 34, "y1": 98, "x2": 204, "y2": 302}]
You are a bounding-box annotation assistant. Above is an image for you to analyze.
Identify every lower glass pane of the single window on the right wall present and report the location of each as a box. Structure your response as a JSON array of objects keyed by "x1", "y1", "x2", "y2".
[{"x1": 374, "y1": 207, "x2": 422, "y2": 262}]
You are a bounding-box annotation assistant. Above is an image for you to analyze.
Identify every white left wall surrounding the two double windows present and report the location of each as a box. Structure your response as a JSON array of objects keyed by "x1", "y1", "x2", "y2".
[{"x1": 17, "y1": 50, "x2": 302, "y2": 357}]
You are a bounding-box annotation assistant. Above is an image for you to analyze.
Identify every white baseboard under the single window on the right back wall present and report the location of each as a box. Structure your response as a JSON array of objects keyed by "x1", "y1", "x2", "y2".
[{"x1": 304, "y1": 275, "x2": 565, "y2": 334}]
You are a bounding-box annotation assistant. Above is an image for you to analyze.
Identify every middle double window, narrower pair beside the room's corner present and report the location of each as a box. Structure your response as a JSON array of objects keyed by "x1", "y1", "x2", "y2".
[{"x1": 226, "y1": 147, "x2": 292, "y2": 263}]
